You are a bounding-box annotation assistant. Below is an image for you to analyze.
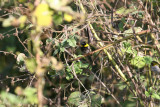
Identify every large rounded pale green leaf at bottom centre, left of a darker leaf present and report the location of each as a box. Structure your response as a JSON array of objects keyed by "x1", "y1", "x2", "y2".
[{"x1": 68, "y1": 91, "x2": 81, "y2": 106}]
